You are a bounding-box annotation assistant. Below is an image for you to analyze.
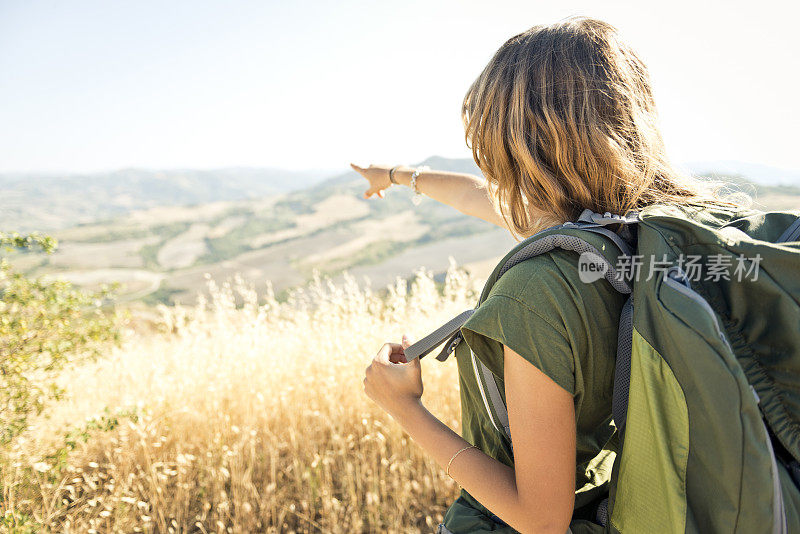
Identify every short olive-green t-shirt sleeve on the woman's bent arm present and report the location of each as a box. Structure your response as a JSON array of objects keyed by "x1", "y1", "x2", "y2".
[{"x1": 461, "y1": 260, "x2": 576, "y2": 395}]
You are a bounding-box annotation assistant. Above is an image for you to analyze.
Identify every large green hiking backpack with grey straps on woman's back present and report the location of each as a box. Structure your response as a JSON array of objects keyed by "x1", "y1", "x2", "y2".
[{"x1": 405, "y1": 205, "x2": 800, "y2": 534}]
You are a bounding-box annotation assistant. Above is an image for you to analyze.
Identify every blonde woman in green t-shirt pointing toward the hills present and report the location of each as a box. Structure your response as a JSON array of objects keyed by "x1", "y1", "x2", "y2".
[{"x1": 353, "y1": 18, "x2": 718, "y2": 534}]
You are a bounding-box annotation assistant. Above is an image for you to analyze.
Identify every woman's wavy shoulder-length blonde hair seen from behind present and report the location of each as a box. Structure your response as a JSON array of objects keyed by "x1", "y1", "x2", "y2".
[{"x1": 462, "y1": 17, "x2": 736, "y2": 236}]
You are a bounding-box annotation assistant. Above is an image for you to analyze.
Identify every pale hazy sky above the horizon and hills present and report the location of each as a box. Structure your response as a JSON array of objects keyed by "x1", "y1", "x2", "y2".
[{"x1": 0, "y1": 0, "x2": 800, "y2": 171}]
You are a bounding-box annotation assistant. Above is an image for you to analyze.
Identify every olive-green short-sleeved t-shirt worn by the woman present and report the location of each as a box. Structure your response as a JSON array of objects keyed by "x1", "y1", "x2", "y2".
[{"x1": 445, "y1": 249, "x2": 627, "y2": 533}]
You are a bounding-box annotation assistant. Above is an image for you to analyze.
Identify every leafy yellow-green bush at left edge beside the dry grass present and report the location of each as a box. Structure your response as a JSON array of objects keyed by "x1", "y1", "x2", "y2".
[{"x1": 0, "y1": 232, "x2": 119, "y2": 445}]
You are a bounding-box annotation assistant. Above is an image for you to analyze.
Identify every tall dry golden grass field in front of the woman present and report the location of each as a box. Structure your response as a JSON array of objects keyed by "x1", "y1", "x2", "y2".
[{"x1": 0, "y1": 267, "x2": 477, "y2": 533}]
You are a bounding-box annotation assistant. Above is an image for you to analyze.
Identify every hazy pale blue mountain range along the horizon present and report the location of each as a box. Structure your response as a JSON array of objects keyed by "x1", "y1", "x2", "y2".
[{"x1": 0, "y1": 156, "x2": 800, "y2": 231}]
